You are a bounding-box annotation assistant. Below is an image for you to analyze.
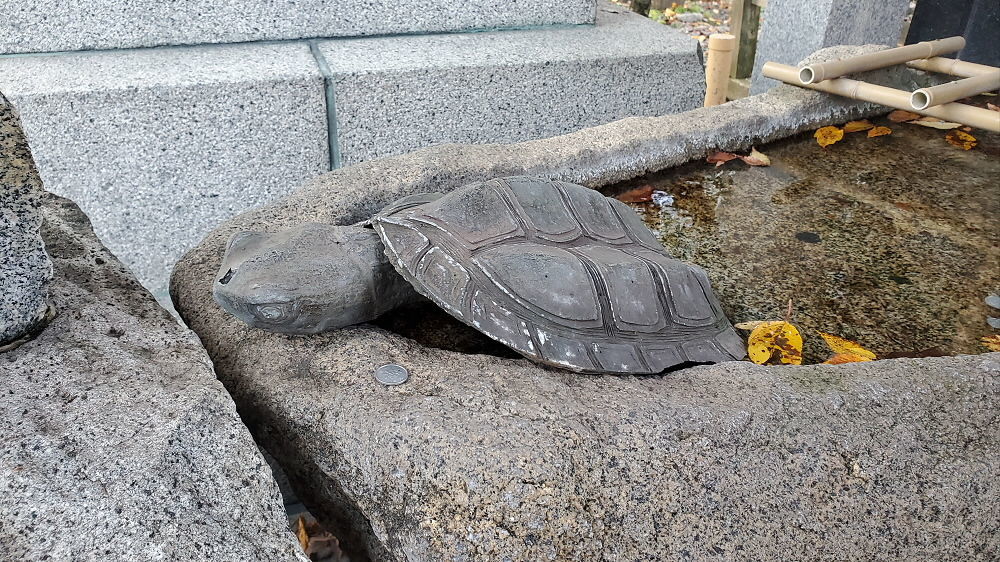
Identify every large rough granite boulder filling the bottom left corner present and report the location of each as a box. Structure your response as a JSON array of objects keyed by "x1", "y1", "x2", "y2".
[{"x1": 0, "y1": 195, "x2": 307, "y2": 562}]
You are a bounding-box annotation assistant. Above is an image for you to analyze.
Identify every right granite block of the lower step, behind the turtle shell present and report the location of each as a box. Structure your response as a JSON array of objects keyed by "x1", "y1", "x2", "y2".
[{"x1": 320, "y1": 2, "x2": 704, "y2": 164}]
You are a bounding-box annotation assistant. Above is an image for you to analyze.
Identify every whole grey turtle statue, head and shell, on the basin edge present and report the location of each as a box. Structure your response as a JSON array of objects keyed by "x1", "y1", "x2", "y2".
[{"x1": 213, "y1": 177, "x2": 744, "y2": 374}]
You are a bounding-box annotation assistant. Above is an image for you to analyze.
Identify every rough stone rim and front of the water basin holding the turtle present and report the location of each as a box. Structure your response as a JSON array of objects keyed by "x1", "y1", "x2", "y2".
[{"x1": 171, "y1": 49, "x2": 1000, "y2": 561}]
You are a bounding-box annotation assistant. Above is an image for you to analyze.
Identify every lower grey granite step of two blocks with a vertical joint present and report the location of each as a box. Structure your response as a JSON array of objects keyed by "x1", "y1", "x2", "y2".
[{"x1": 0, "y1": 4, "x2": 703, "y2": 295}]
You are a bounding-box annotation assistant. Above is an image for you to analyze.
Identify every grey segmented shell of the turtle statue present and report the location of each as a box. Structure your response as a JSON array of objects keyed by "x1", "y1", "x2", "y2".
[{"x1": 372, "y1": 177, "x2": 744, "y2": 373}]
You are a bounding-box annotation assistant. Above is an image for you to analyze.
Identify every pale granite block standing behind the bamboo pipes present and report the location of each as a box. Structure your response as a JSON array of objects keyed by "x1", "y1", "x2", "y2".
[{"x1": 750, "y1": 0, "x2": 910, "y2": 94}]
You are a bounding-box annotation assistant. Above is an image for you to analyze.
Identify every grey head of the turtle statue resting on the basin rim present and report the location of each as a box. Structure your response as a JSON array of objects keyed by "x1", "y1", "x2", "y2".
[{"x1": 212, "y1": 223, "x2": 396, "y2": 334}]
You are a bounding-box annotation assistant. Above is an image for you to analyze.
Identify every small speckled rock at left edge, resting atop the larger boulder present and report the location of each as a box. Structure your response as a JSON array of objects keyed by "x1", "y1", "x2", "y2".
[{"x1": 0, "y1": 92, "x2": 52, "y2": 349}]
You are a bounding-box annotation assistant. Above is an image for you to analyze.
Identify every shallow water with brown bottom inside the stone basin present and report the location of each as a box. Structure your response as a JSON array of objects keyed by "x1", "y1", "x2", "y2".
[{"x1": 602, "y1": 112, "x2": 1000, "y2": 362}]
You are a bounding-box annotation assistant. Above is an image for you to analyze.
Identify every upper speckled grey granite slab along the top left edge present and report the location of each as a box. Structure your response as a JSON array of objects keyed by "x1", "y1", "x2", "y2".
[{"x1": 0, "y1": 0, "x2": 594, "y2": 53}]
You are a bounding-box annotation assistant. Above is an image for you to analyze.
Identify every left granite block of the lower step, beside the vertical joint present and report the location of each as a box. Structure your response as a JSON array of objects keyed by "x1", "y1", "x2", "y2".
[{"x1": 0, "y1": 44, "x2": 329, "y2": 298}]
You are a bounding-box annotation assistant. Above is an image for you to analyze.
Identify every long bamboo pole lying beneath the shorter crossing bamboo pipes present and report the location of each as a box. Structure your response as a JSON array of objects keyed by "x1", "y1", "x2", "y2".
[{"x1": 762, "y1": 62, "x2": 1000, "y2": 133}]
